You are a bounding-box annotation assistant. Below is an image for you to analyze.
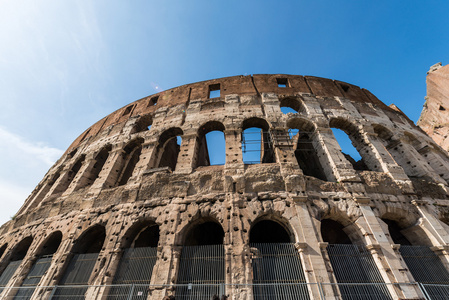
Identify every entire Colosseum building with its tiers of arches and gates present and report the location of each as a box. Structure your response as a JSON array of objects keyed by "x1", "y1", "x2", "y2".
[{"x1": 0, "y1": 74, "x2": 449, "y2": 300}]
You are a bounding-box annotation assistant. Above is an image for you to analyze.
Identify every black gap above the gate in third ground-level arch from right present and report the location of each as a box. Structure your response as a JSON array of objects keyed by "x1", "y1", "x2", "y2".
[{"x1": 249, "y1": 220, "x2": 292, "y2": 244}]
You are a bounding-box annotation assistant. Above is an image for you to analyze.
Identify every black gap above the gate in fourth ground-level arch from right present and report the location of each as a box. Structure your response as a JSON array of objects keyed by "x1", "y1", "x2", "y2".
[{"x1": 184, "y1": 221, "x2": 224, "y2": 246}]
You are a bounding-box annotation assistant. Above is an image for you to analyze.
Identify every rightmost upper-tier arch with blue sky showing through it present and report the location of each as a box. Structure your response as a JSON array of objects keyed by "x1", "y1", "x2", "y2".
[{"x1": 329, "y1": 117, "x2": 370, "y2": 171}]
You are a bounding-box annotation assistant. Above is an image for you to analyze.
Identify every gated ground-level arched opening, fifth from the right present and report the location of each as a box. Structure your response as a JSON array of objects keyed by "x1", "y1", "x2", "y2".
[{"x1": 108, "y1": 221, "x2": 159, "y2": 299}]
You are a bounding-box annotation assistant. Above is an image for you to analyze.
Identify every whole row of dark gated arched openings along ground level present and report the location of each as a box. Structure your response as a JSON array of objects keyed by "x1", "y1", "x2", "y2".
[{"x1": 0, "y1": 212, "x2": 449, "y2": 299}]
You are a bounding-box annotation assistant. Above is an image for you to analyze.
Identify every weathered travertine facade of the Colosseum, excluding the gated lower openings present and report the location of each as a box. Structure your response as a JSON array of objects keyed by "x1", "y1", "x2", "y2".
[{"x1": 0, "y1": 71, "x2": 449, "y2": 299}]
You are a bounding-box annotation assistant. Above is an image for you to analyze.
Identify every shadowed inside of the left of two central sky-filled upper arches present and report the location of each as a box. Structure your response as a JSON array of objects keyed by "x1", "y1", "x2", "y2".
[{"x1": 194, "y1": 121, "x2": 226, "y2": 167}]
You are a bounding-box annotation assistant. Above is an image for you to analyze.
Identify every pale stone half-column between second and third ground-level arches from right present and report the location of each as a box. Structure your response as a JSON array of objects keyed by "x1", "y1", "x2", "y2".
[{"x1": 292, "y1": 196, "x2": 338, "y2": 299}]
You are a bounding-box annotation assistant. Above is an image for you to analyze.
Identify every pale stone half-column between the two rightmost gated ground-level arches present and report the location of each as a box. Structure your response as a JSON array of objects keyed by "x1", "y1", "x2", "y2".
[{"x1": 355, "y1": 197, "x2": 420, "y2": 299}]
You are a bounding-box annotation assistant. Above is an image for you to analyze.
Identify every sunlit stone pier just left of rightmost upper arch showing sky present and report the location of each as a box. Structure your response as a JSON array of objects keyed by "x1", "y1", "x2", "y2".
[{"x1": 310, "y1": 127, "x2": 360, "y2": 182}]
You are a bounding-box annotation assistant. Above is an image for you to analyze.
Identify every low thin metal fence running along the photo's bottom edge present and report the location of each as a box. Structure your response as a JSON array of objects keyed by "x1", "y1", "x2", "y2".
[{"x1": 0, "y1": 283, "x2": 449, "y2": 300}]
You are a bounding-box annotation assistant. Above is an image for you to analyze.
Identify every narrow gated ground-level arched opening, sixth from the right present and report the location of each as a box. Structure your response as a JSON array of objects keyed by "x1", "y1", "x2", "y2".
[{"x1": 55, "y1": 225, "x2": 106, "y2": 298}]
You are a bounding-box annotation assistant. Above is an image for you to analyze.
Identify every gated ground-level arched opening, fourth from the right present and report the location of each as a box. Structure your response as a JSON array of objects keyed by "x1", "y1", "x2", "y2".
[{"x1": 175, "y1": 219, "x2": 225, "y2": 300}]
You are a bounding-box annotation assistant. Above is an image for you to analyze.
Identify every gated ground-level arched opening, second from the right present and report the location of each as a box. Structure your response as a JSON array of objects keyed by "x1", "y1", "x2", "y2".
[{"x1": 321, "y1": 219, "x2": 392, "y2": 300}]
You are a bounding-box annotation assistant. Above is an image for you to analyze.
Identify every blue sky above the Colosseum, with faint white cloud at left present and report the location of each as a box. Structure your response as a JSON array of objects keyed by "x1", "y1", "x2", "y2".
[{"x1": 0, "y1": 0, "x2": 449, "y2": 223}]
